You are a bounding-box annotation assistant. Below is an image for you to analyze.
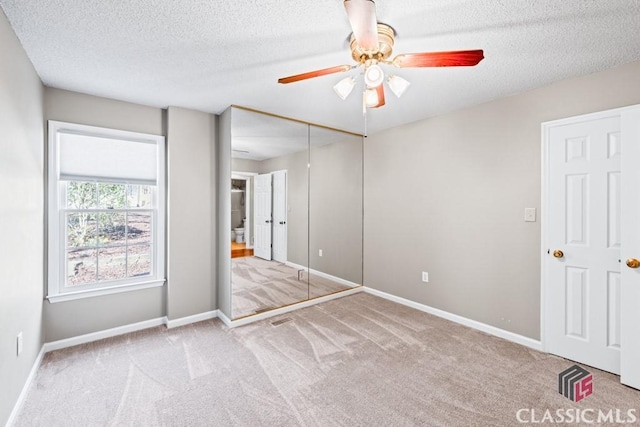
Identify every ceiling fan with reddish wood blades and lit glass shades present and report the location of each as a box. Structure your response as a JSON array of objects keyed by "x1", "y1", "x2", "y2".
[{"x1": 278, "y1": 0, "x2": 484, "y2": 112}]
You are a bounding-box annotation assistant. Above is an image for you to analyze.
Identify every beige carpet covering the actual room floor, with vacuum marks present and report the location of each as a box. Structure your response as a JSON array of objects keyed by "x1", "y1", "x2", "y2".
[{"x1": 17, "y1": 293, "x2": 640, "y2": 427}]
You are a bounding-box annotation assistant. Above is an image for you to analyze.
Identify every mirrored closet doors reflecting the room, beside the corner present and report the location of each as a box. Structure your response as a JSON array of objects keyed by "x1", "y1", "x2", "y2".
[{"x1": 230, "y1": 109, "x2": 362, "y2": 319}]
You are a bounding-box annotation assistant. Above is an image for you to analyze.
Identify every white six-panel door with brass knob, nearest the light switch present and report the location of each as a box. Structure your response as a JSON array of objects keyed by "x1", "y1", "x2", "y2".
[{"x1": 545, "y1": 113, "x2": 621, "y2": 373}]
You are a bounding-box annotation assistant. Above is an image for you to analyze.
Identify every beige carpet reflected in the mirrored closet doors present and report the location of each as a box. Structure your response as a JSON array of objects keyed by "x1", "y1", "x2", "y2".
[{"x1": 231, "y1": 257, "x2": 350, "y2": 319}]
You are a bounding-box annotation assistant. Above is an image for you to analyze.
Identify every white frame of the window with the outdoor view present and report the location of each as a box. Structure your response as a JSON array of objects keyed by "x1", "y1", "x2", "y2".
[{"x1": 46, "y1": 120, "x2": 166, "y2": 303}]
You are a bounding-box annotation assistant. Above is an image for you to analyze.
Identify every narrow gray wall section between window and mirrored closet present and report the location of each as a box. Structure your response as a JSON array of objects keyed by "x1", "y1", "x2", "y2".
[{"x1": 167, "y1": 107, "x2": 217, "y2": 320}]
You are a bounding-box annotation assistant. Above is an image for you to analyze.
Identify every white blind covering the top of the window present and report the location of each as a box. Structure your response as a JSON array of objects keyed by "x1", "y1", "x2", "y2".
[{"x1": 58, "y1": 131, "x2": 158, "y2": 185}]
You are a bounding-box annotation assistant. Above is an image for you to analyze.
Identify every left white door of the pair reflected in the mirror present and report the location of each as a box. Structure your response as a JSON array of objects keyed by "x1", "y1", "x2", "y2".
[{"x1": 253, "y1": 174, "x2": 272, "y2": 260}]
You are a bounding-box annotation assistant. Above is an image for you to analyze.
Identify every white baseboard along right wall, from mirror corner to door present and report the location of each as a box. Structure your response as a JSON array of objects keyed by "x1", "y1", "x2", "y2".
[{"x1": 364, "y1": 287, "x2": 544, "y2": 351}]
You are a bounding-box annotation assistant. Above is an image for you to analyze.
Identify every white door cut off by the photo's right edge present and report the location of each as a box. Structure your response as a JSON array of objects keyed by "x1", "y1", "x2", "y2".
[{"x1": 620, "y1": 107, "x2": 640, "y2": 389}]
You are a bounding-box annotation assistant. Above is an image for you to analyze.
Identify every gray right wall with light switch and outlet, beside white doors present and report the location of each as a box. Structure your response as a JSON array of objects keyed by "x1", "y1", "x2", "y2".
[{"x1": 364, "y1": 62, "x2": 640, "y2": 339}]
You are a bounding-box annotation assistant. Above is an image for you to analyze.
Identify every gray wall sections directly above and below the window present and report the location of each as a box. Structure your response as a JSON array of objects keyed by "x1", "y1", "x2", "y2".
[{"x1": 44, "y1": 88, "x2": 165, "y2": 342}]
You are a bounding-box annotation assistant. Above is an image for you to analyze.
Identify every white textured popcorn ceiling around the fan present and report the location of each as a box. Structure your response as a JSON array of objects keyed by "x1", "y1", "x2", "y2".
[{"x1": 0, "y1": 0, "x2": 640, "y2": 133}]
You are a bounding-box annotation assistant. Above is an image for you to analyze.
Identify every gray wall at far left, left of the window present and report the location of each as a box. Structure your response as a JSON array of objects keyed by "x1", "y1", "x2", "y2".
[{"x1": 0, "y1": 11, "x2": 44, "y2": 425}]
